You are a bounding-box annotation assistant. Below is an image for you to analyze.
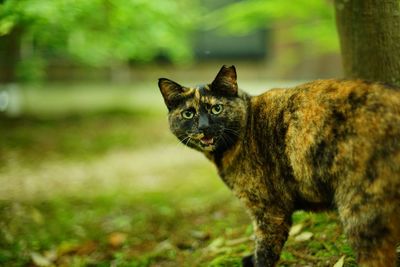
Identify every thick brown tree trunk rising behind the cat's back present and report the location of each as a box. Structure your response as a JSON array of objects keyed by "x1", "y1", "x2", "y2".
[{"x1": 335, "y1": 0, "x2": 400, "y2": 86}]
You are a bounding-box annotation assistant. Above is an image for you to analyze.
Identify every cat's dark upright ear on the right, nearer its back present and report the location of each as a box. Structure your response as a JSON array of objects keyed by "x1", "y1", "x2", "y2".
[{"x1": 211, "y1": 65, "x2": 238, "y2": 96}]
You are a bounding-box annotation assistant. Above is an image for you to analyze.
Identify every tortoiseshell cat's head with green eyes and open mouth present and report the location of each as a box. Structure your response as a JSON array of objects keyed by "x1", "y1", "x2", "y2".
[{"x1": 158, "y1": 66, "x2": 247, "y2": 153}]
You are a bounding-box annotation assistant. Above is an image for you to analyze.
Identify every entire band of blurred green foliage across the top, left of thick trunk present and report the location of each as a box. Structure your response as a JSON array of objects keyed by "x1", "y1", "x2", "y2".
[{"x1": 0, "y1": 0, "x2": 338, "y2": 81}]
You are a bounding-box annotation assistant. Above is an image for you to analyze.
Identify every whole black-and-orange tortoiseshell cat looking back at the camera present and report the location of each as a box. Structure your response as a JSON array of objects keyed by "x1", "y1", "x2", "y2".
[{"x1": 158, "y1": 66, "x2": 400, "y2": 267}]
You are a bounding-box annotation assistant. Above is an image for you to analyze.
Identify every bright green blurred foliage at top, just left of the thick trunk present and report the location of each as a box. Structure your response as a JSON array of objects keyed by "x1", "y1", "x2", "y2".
[{"x1": 204, "y1": 0, "x2": 339, "y2": 52}]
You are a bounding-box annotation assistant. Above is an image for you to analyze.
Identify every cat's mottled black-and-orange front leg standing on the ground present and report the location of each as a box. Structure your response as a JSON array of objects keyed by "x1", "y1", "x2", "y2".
[{"x1": 243, "y1": 214, "x2": 291, "y2": 267}]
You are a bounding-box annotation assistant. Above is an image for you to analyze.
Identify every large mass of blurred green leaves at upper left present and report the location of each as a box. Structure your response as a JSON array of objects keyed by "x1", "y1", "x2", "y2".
[{"x1": 0, "y1": 0, "x2": 198, "y2": 66}]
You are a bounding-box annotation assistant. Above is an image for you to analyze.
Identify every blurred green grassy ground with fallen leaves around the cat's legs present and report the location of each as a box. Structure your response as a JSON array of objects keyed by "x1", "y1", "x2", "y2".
[{"x1": 0, "y1": 82, "x2": 355, "y2": 267}]
